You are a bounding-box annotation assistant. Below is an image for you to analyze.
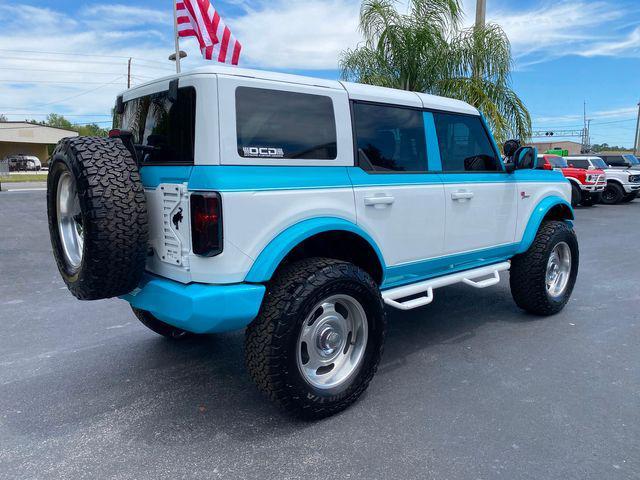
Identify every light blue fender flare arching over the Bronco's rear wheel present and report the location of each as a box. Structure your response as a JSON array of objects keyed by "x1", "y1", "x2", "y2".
[{"x1": 245, "y1": 217, "x2": 386, "y2": 283}]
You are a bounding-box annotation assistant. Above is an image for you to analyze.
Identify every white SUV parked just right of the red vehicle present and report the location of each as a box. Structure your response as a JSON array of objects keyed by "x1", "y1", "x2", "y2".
[{"x1": 566, "y1": 155, "x2": 640, "y2": 205}]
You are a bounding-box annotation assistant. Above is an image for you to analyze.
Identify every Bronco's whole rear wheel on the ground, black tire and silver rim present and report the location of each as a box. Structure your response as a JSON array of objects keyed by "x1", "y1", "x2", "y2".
[{"x1": 245, "y1": 258, "x2": 386, "y2": 419}]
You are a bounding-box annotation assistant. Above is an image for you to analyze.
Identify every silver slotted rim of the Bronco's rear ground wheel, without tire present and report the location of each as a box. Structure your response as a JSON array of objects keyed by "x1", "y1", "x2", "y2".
[{"x1": 296, "y1": 295, "x2": 368, "y2": 389}]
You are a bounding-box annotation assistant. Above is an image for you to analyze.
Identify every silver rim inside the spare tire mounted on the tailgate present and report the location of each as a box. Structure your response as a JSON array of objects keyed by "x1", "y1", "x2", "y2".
[{"x1": 56, "y1": 172, "x2": 84, "y2": 269}]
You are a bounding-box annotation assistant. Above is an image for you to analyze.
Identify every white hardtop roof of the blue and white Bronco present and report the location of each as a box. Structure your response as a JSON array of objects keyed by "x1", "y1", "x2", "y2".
[{"x1": 128, "y1": 65, "x2": 479, "y2": 115}]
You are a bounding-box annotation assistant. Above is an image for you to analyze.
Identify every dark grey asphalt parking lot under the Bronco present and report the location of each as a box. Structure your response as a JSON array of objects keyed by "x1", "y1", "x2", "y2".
[{"x1": 0, "y1": 191, "x2": 640, "y2": 480}]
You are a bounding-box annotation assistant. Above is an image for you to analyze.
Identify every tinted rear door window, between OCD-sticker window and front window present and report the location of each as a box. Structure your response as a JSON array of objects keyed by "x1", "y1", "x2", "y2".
[{"x1": 353, "y1": 102, "x2": 428, "y2": 172}]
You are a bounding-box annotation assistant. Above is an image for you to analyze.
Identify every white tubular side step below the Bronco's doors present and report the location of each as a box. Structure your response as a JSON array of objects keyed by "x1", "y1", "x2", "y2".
[{"x1": 382, "y1": 262, "x2": 511, "y2": 310}]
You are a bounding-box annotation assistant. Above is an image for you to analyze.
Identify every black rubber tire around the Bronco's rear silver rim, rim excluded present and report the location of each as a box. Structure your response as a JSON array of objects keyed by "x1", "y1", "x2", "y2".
[{"x1": 245, "y1": 258, "x2": 386, "y2": 419}]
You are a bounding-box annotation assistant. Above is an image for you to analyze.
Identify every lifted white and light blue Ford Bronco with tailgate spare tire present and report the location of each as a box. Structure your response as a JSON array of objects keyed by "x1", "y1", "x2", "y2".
[{"x1": 47, "y1": 67, "x2": 578, "y2": 418}]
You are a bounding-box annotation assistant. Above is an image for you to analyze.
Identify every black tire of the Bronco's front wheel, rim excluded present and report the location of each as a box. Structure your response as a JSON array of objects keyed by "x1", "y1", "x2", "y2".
[{"x1": 509, "y1": 221, "x2": 580, "y2": 315}]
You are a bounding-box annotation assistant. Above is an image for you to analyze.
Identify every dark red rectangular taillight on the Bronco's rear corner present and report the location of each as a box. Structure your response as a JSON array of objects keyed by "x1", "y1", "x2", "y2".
[{"x1": 191, "y1": 193, "x2": 222, "y2": 257}]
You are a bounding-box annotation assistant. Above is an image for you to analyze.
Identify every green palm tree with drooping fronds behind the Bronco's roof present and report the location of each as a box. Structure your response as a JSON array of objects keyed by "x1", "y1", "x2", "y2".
[{"x1": 340, "y1": 0, "x2": 531, "y2": 142}]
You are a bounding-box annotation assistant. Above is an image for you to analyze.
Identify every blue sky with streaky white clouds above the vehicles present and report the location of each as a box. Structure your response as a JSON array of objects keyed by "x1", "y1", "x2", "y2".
[{"x1": 0, "y1": 0, "x2": 640, "y2": 146}]
